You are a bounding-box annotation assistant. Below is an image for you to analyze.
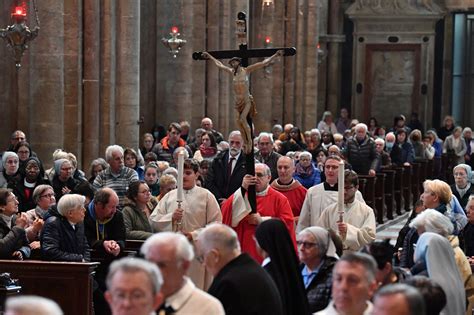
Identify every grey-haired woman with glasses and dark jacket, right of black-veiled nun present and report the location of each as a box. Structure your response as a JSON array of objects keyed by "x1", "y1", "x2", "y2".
[{"x1": 296, "y1": 226, "x2": 338, "y2": 313}]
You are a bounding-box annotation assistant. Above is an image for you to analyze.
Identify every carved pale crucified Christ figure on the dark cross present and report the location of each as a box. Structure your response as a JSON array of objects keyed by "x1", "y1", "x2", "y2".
[{"x1": 202, "y1": 50, "x2": 284, "y2": 154}]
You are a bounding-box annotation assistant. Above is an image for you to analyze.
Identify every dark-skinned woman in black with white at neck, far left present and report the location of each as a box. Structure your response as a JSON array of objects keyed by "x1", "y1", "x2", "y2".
[{"x1": 8, "y1": 157, "x2": 48, "y2": 212}]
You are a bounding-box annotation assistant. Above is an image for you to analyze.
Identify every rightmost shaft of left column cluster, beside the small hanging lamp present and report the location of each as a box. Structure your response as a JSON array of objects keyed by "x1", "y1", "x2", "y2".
[{"x1": 115, "y1": 0, "x2": 140, "y2": 148}]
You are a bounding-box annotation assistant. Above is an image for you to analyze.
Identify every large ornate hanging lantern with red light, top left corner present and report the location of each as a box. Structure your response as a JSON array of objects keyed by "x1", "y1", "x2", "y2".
[{"x1": 0, "y1": 0, "x2": 40, "y2": 69}]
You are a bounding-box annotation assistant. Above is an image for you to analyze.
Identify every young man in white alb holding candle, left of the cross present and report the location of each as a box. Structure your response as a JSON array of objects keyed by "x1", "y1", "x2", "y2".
[{"x1": 150, "y1": 159, "x2": 222, "y2": 290}]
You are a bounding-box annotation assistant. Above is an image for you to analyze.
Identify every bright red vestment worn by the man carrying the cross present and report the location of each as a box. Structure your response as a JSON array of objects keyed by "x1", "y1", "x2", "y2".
[{"x1": 222, "y1": 187, "x2": 296, "y2": 263}]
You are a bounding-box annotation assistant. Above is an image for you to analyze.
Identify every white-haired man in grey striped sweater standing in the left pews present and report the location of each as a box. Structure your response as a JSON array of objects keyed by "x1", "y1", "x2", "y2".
[{"x1": 93, "y1": 145, "x2": 138, "y2": 207}]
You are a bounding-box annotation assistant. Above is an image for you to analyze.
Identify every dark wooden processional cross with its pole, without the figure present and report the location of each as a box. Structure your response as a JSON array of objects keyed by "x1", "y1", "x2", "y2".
[{"x1": 193, "y1": 12, "x2": 296, "y2": 213}]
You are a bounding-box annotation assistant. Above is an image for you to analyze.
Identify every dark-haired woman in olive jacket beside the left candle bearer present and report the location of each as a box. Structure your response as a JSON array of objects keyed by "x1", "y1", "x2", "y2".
[{"x1": 122, "y1": 181, "x2": 158, "y2": 240}]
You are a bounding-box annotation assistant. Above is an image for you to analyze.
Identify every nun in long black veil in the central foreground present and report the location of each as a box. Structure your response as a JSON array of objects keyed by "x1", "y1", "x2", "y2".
[{"x1": 255, "y1": 219, "x2": 312, "y2": 315}]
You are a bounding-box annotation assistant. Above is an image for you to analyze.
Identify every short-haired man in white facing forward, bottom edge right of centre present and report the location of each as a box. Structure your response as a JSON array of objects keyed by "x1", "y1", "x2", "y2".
[{"x1": 315, "y1": 253, "x2": 377, "y2": 315}]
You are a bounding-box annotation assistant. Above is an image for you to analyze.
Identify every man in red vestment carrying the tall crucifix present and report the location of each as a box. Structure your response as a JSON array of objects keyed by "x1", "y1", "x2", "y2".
[{"x1": 222, "y1": 163, "x2": 296, "y2": 262}]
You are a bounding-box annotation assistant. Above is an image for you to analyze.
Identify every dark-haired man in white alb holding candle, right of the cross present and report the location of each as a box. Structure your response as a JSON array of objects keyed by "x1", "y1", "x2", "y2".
[{"x1": 316, "y1": 170, "x2": 375, "y2": 251}]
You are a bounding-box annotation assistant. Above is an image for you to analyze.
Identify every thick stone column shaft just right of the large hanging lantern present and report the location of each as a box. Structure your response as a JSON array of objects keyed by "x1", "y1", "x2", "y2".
[{"x1": 25, "y1": 0, "x2": 64, "y2": 161}]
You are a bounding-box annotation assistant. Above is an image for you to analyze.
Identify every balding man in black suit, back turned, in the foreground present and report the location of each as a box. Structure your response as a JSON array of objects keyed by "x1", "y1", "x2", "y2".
[{"x1": 196, "y1": 223, "x2": 283, "y2": 315}]
